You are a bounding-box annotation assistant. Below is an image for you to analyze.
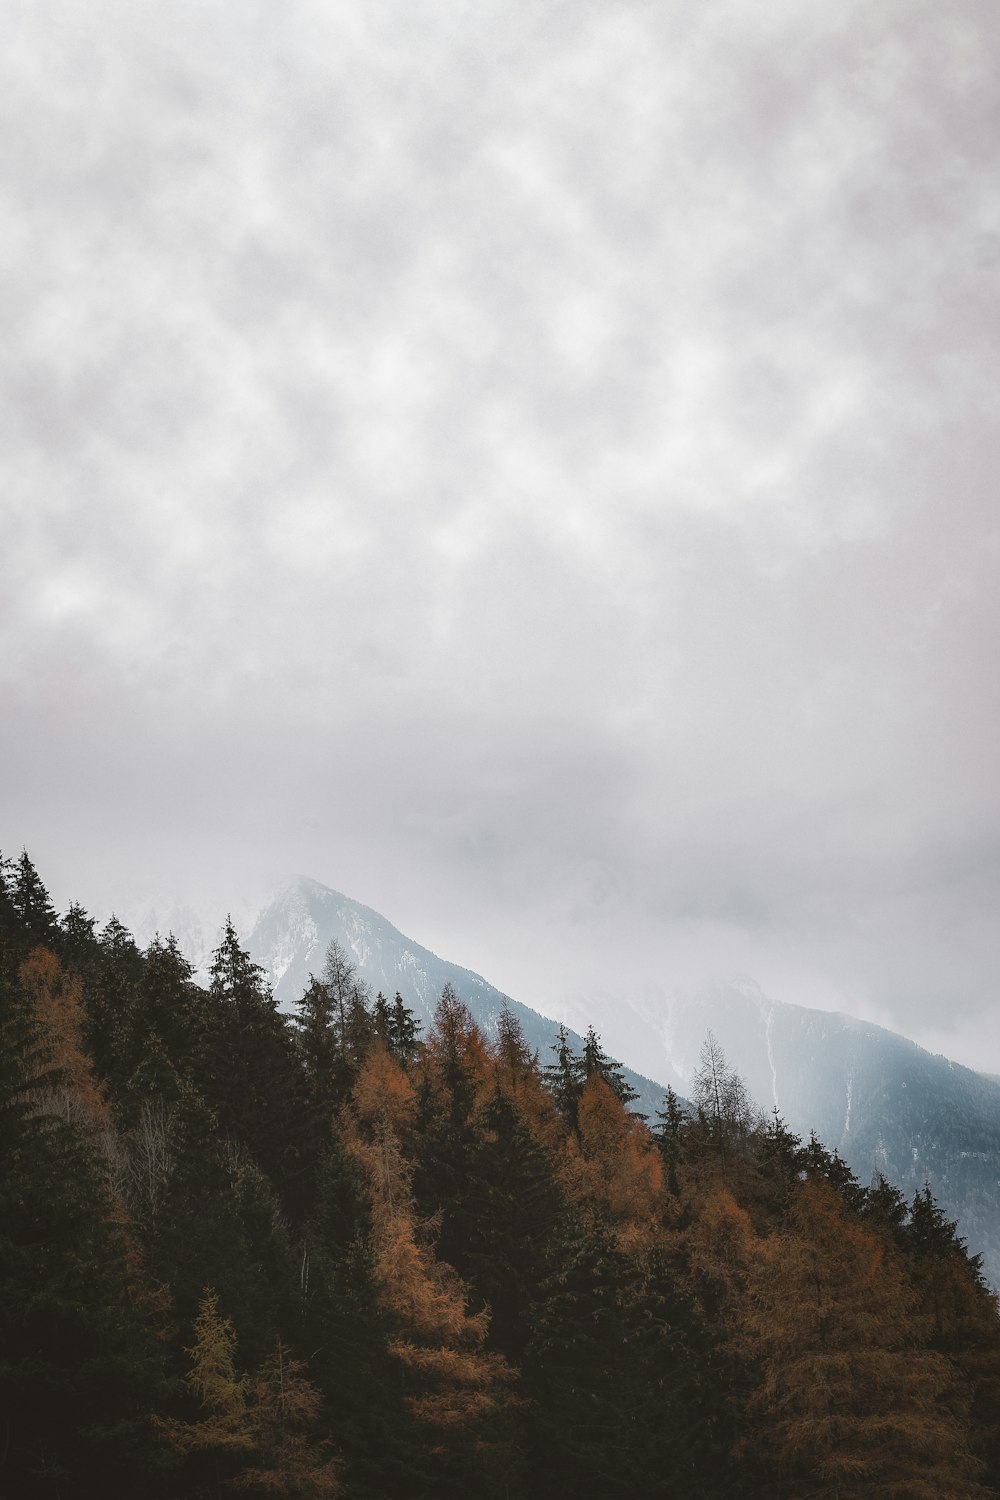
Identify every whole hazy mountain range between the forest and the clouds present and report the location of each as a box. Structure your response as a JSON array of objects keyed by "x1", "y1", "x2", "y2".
[{"x1": 247, "y1": 879, "x2": 1000, "y2": 1286}]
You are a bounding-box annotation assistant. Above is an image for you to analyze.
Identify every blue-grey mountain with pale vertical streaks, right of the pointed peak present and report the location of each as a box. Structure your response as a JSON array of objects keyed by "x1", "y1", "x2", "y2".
[{"x1": 646, "y1": 981, "x2": 1000, "y2": 1286}]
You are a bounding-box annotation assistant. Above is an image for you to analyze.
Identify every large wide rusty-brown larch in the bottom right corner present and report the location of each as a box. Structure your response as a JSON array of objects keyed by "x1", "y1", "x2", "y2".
[{"x1": 735, "y1": 1181, "x2": 982, "y2": 1500}]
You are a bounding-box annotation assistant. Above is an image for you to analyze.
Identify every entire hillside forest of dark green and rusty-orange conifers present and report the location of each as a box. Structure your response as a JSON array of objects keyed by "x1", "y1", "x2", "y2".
[{"x1": 0, "y1": 855, "x2": 1000, "y2": 1500}]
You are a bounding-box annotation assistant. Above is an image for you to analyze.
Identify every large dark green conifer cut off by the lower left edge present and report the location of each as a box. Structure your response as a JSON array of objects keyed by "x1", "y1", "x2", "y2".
[{"x1": 0, "y1": 971, "x2": 160, "y2": 1500}]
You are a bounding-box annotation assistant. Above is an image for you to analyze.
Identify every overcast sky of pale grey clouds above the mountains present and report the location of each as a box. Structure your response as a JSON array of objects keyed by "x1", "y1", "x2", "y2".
[{"x1": 0, "y1": 0, "x2": 1000, "y2": 1071}]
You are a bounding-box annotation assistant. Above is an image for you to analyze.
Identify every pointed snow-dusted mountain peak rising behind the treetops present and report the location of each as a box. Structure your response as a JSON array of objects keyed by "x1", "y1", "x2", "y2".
[{"x1": 247, "y1": 878, "x2": 664, "y2": 1116}]
